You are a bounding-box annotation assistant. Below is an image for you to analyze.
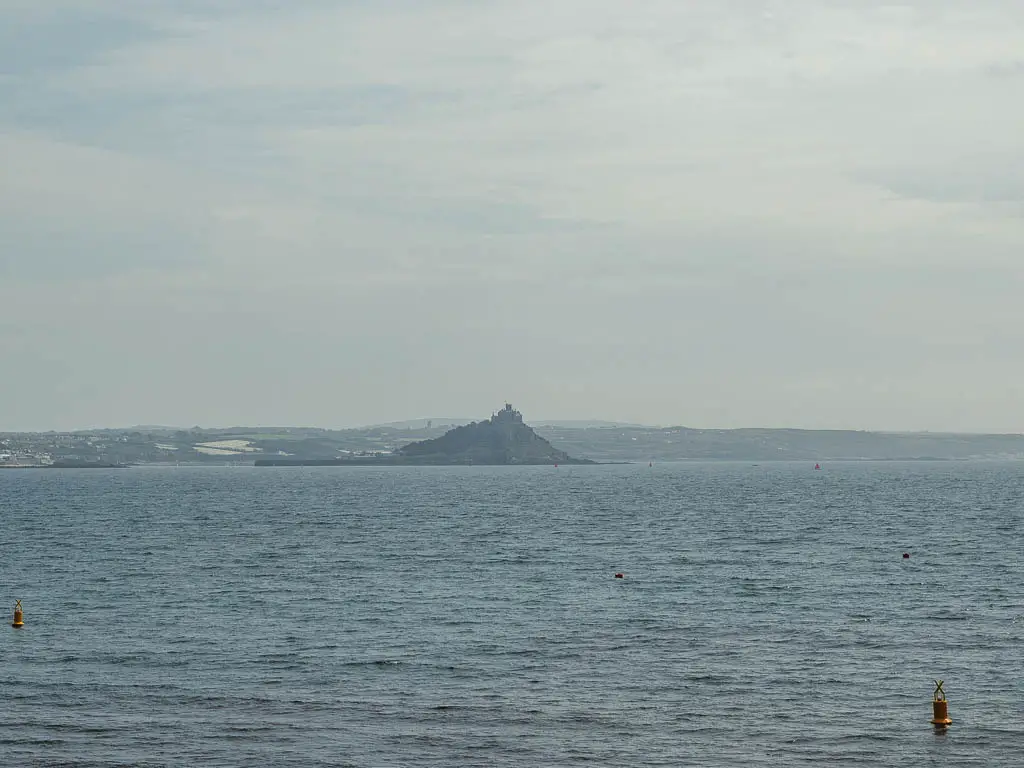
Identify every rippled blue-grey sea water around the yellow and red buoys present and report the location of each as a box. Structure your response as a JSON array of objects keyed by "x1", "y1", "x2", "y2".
[{"x1": 0, "y1": 463, "x2": 1024, "y2": 768}]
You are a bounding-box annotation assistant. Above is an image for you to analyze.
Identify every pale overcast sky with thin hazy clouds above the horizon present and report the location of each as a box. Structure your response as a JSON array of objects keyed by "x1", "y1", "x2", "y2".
[{"x1": 0, "y1": 0, "x2": 1024, "y2": 432}]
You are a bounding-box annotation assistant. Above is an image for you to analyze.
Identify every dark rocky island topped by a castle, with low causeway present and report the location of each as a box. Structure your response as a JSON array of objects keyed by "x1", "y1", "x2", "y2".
[{"x1": 255, "y1": 403, "x2": 595, "y2": 467}]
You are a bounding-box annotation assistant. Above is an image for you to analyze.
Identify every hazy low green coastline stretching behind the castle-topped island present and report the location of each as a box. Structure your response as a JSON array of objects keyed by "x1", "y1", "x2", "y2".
[{"x1": 6, "y1": 419, "x2": 1024, "y2": 469}]
